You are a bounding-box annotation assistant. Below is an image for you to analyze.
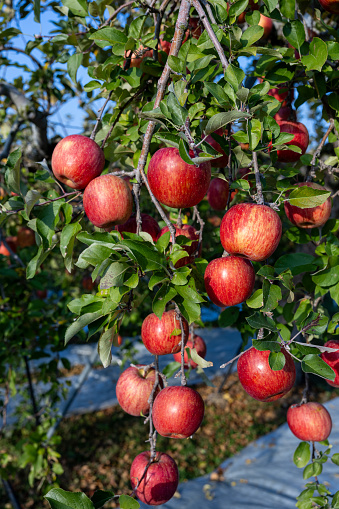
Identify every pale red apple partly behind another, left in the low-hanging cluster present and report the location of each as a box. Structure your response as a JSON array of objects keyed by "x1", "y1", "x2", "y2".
[{"x1": 116, "y1": 364, "x2": 162, "y2": 417}]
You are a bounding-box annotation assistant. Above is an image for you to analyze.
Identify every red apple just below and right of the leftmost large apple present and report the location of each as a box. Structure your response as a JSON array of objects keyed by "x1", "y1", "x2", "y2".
[{"x1": 83, "y1": 174, "x2": 133, "y2": 228}]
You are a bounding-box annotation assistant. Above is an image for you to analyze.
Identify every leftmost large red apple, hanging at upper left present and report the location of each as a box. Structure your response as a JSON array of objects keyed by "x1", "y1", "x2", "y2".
[{"x1": 52, "y1": 134, "x2": 105, "y2": 189}]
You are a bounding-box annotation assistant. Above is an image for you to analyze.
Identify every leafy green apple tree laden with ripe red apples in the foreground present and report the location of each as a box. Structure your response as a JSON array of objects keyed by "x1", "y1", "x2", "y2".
[{"x1": 0, "y1": 0, "x2": 339, "y2": 509}]
